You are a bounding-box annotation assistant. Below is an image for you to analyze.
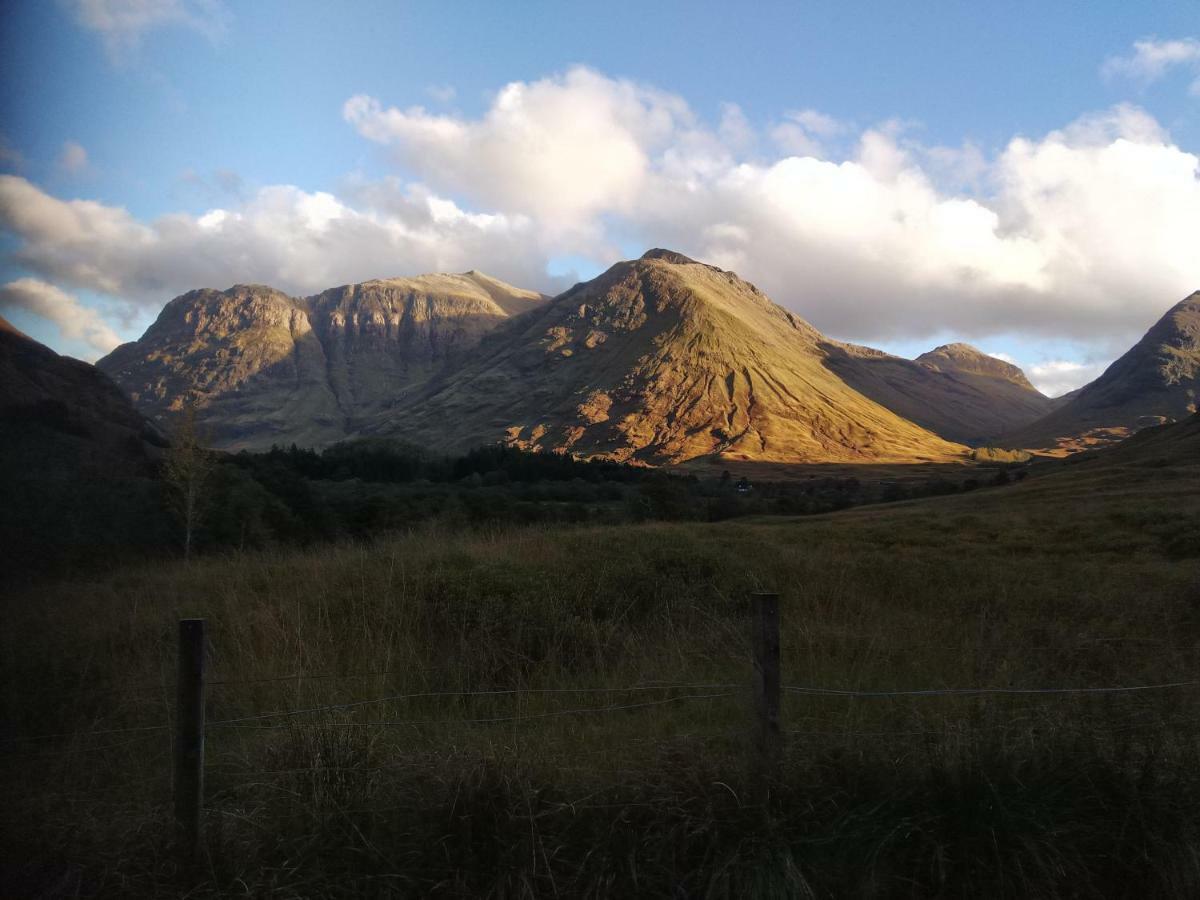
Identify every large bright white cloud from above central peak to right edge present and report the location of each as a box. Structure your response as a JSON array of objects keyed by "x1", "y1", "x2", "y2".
[{"x1": 344, "y1": 68, "x2": 1200, "y2": 348}]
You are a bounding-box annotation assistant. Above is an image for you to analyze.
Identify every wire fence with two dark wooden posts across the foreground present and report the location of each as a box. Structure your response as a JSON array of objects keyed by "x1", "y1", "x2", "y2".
[{"x1": 0, "y1": 595, "x2": 1200, "y2": 844}]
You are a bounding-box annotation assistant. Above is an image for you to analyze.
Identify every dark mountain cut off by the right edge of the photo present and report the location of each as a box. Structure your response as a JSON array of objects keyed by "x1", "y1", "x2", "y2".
[{"x1": 1003, "y1": 290, "x2": 1200, "y2": 451}]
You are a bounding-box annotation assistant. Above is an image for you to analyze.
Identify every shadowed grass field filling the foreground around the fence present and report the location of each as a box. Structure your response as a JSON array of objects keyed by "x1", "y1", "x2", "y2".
[{"x1": 0, "y1": 427, "x2": 1200, "y2": 896}]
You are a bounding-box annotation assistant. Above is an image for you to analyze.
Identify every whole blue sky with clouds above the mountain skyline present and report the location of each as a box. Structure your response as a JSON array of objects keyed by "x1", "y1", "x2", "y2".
[{"x1": 0, "y1": 0, "x2": 1200, "y2": 395}]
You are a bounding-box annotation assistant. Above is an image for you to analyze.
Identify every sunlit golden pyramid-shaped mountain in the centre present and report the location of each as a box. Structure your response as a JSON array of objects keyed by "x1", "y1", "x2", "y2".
[{"x1": 370, "y1": 251, "x2": 962, "y2": 462}]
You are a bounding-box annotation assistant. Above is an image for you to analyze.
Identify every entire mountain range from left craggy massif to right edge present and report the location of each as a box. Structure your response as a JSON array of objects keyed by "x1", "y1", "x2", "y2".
[{"x1": 42, "y1": 250, "x2": 1185, "y2": 464}]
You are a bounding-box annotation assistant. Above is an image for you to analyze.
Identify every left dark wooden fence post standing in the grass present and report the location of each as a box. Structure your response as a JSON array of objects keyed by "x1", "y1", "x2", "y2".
[{"x1": 175, "y1": 619, "x2": 204, "y2": 860}]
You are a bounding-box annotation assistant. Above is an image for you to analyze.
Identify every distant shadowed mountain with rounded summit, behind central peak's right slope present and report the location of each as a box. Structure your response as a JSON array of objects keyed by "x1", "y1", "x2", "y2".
[{"x1": 822, "y1": 341, "x2": 1054, "y2": 445}]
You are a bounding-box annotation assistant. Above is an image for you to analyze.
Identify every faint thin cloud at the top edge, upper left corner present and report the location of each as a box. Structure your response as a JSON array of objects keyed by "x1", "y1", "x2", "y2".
[{"x1": 64, "y1": 0, "x2": 229, "y2": 62}]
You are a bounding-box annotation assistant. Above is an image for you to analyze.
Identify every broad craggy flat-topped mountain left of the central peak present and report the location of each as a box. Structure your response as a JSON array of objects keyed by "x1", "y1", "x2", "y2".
[{"x1": 97, "y1": 271, "x2": 546, "y2": 449}]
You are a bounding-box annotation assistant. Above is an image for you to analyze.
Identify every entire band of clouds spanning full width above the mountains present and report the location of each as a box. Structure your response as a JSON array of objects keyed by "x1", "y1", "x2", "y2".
[{"x1": 0, "y1": 68, "x2": 1200, "y2": 376}]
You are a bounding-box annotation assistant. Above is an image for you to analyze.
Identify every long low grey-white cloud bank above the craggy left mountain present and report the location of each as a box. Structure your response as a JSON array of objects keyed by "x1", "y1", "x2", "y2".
[{"x1": 0, "y1": 175, "x2": 547, "y2": 306}]
